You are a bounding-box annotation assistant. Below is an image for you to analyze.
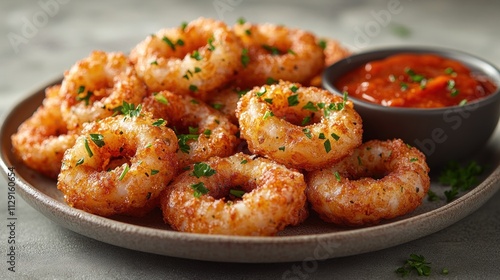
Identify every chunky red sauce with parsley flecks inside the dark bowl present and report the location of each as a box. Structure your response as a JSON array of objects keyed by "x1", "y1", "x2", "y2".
[{"x1": 335, "y1": 54, "x2": 496, "y2": 108}]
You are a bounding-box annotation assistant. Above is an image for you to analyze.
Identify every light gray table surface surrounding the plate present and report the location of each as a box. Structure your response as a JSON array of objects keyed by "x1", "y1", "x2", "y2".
[{"x1": 0, "y1": 0, "x2": 500, "y2": 280}]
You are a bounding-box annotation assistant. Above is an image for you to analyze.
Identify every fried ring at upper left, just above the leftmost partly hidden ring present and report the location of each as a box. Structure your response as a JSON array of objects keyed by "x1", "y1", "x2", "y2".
[{"x1": 60, "y1": 51, "x2": 146, "y2": 129}]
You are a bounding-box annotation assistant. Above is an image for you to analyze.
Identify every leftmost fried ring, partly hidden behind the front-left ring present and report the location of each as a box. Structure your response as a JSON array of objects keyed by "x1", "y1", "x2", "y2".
[{"x1": 11, "y1": 85, "x2": 78, "y2": 178}]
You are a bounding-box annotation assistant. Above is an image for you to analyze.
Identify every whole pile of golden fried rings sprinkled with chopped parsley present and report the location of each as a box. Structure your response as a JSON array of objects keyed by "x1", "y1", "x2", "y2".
[{"x1": 12, "y1": 18, "x2": 429, "y2": 235}]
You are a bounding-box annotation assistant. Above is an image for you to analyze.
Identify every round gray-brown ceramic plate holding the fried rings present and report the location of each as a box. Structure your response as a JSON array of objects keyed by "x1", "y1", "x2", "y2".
[{"x1": 0, "y1": 80, "x2": 500, "y2": 263}]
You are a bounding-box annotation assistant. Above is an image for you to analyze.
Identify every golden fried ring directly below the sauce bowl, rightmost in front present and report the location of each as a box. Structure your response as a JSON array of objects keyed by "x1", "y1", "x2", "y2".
[{"x1": 307, "y1": 139, "x2": 430, "y2": 226}]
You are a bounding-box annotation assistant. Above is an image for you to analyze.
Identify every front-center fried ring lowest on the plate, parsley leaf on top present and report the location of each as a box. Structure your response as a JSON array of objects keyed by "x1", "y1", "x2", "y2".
[{"x1": 161, "y1": 153, "x2": 308, "y2": 235}]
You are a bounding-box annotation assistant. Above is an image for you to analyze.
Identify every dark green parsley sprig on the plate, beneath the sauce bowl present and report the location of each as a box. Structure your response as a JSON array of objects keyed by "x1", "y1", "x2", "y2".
[{"x1": 439, "y1": 161, "x2": 484, "y2": 202}]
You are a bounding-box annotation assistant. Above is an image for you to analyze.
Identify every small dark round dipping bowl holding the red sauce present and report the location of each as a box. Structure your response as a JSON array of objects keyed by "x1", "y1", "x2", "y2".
[{"x1": 322, "y1": 48, "x2": 500, "y2": 168}]
